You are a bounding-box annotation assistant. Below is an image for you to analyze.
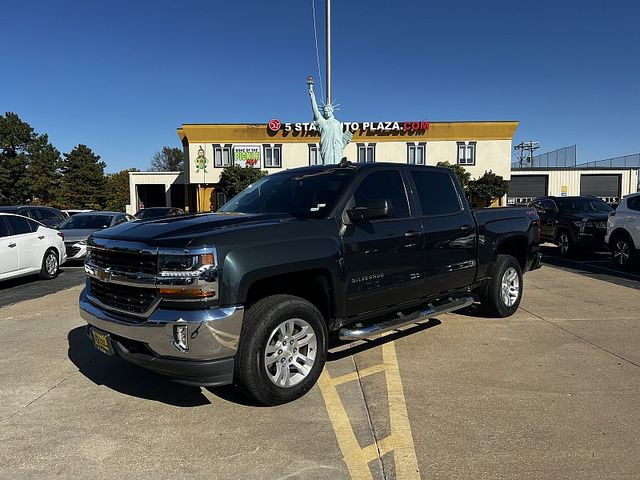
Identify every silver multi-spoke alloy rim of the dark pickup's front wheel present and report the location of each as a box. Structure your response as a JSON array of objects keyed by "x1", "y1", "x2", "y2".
[{"x1": 264, "y1": 318, "x2": 318, "y2": 388}]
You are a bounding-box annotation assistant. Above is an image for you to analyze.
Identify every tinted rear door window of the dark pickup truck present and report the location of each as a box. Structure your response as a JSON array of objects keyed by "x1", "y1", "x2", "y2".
[{"x1": 411, "y1": 170, "x2": 461, "y2": 215}]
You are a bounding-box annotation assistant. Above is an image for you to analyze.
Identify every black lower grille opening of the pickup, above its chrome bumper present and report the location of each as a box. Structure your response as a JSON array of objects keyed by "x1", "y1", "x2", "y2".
[{"x1": 89, "y1": 278, "x2": 158, "y2": 315}]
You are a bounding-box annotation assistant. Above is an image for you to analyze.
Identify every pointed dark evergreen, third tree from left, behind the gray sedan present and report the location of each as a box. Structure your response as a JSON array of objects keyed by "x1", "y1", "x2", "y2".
[{"x1": 60, "y1": 144, "x2": 106, "y2": 209}]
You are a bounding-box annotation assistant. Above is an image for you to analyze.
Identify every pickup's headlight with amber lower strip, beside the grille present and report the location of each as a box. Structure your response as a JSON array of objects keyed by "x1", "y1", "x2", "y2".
[{"x1": 156, "y1": 248, "x2": 218, "y2": 299}]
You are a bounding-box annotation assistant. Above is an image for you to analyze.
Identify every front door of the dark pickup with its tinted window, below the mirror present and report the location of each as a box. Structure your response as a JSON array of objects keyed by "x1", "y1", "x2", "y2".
[{"x1": 342, "y1": 169, "x2": 424, "y2": 316}]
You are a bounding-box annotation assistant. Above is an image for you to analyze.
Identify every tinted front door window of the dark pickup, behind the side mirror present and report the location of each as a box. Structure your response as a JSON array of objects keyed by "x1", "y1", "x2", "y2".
[{"x1": 353, "y1": 170, "x2": 409, "y2": 218}]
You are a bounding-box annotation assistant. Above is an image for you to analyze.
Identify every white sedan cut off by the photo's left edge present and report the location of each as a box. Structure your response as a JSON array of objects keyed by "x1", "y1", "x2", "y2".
[{"x1": 0, "y1": 212, "x2": 67, "y2": 280}]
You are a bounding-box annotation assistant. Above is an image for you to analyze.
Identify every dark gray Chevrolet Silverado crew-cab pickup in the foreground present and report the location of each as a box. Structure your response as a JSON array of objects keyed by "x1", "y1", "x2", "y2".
[{"x1": 80, "y1": 163, "x2": 541, "y2": 405}]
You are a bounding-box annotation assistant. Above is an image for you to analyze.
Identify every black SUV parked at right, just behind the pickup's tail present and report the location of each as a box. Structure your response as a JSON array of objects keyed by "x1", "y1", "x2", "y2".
[{"x1": 530, "y1": 196, "x2": 613, "y2": 257}]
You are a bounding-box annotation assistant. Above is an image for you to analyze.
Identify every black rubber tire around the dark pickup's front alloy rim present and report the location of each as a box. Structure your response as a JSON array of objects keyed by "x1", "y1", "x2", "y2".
[{"x1": 235, "y1": 295, "x2": 328, "y2": 405}]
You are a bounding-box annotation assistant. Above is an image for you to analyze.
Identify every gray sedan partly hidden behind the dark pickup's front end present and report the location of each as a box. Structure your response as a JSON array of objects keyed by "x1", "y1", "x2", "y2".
[{"x1": 58, "y1": 211, "x2": 134, "y2": 260}]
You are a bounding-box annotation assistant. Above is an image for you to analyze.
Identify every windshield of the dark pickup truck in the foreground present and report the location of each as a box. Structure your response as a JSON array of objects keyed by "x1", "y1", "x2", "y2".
[{"x1": 219, "y1": 168, "x2": 353, "y2": 218}]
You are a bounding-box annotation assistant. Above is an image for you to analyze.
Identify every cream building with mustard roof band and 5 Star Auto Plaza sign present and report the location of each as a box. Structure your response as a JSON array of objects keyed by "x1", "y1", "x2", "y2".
[{"x1": 128, "y1": 119, "x2": 518, "y2": 213}]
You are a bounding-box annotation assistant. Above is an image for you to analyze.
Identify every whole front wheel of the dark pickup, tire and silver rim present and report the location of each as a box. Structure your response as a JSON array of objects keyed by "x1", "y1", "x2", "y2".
[{"x1": 236, "y1": 295, "x2": 328, "y2": 405}]
